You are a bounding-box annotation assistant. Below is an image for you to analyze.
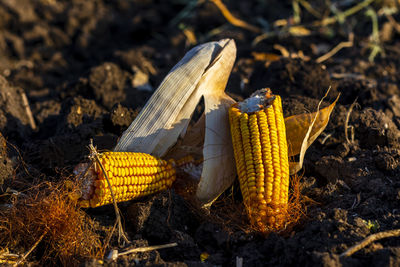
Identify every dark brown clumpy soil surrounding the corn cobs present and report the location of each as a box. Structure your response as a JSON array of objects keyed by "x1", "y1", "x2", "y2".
[{"x1": 0, "y1": 0, "x2": 400, "y2": 266}]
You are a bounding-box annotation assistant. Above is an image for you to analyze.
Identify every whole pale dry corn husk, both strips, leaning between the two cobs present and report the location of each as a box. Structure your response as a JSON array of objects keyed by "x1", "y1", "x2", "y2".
[{"x1": 114, "y1": 39, "x2": 236, "y2": 204}]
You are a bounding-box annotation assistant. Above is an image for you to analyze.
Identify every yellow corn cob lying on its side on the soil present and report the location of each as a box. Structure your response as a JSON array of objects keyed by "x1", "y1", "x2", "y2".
[{"x1": 75, "y1": 152, "x2": 177, "y2": 208}]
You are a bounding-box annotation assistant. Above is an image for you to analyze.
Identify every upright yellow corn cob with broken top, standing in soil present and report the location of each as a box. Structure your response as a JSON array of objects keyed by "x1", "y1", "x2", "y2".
[{"x1": 229, "y1": 89, "x2": 289, "y2": 231}]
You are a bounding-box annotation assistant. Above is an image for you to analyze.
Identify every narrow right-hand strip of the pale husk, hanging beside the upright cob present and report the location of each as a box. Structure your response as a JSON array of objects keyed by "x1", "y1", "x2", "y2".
[{"x1": 192, "y1": 42, "x2": 236, "y2": 204}]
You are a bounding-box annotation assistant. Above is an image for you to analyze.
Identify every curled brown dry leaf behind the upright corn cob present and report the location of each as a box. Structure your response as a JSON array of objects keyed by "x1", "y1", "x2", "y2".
[{"x1": 285, "y1": 90, "x2": 340, "y2": 174}]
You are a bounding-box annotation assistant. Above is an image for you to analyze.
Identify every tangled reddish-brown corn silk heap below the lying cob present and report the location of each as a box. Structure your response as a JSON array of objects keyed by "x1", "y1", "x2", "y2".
[{"x1": 0, "y1": 182, "x2": 104, "y2": 266}]
